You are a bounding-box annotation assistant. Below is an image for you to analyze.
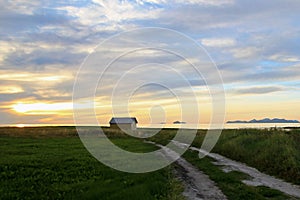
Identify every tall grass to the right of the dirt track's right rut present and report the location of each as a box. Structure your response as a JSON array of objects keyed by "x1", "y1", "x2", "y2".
[{"x1": 150, "y1": 129, "x2": 300, "y2": 185}]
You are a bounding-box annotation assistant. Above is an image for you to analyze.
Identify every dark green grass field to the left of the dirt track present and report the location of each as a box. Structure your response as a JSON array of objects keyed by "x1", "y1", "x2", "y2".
[{"x1": 0, "y1": 127, "x2": 183, "y2": 200}]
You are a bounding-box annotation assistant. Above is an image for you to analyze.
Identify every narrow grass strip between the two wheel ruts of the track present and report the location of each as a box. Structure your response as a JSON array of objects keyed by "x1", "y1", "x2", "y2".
[{"x1": 184, "y1": 151, "x2": 288, "y2": 200}]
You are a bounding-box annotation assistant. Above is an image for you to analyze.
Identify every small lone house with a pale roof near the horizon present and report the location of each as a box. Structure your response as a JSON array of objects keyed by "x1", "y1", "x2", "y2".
[{"x1": 109, "y1": 117, "x2": 138, "y2": 130}]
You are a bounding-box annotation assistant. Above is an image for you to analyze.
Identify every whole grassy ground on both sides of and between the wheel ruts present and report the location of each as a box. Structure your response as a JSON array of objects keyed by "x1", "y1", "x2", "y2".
[{"x1": 0, "y1": 127, "x2": 300, "y2": 200}]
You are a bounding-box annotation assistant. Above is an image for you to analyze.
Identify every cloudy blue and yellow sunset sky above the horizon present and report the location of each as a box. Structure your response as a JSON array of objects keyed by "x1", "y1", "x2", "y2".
[{"x1": 0, "y1": 0, "x2": 300, "y2": 124}]
